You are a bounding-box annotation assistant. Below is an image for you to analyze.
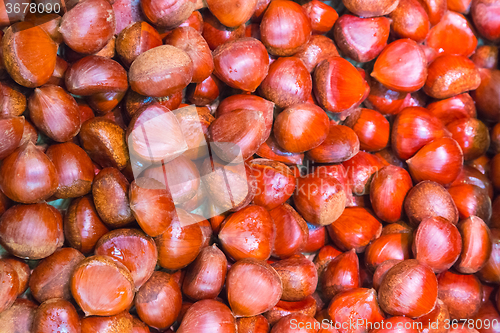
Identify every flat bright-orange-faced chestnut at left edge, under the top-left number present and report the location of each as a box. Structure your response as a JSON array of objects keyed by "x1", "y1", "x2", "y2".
[{"x1": 2, "y1": 22, "x2": 57, "y2": 88}]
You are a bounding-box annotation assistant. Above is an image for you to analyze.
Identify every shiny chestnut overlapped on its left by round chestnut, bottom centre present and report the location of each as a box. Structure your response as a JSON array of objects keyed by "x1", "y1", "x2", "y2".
[{"x1": 271, "y1": 254, "x2": 318, "y2": 302}]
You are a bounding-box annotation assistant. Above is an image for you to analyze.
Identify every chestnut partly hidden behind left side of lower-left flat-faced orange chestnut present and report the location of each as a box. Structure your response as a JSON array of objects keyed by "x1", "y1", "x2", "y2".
[{"x1": 29, "y1": 247, "x2": 85, "y2": 303}]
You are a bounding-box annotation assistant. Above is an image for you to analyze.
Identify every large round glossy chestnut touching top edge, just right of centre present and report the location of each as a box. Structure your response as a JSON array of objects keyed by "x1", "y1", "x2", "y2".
[{"x1": 260, "y1": 0, "x2": 311, "y2": 57}]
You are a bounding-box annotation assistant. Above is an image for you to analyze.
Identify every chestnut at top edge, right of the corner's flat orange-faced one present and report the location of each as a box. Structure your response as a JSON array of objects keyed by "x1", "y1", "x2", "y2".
[{"x1": 59, "y1": 0, "x2": 116, "y2": 54}]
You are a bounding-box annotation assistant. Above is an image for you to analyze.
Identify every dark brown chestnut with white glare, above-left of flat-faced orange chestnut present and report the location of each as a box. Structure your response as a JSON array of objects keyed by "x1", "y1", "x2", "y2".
[{"x1": 64, "y1": 196, "x2": 109, "y2": 254}]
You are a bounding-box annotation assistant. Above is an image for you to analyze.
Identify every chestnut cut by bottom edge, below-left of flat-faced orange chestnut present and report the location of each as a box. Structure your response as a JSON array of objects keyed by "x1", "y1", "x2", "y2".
[{"x1": 32, "y1": 298, "x2": 81, "y2": 333}]
